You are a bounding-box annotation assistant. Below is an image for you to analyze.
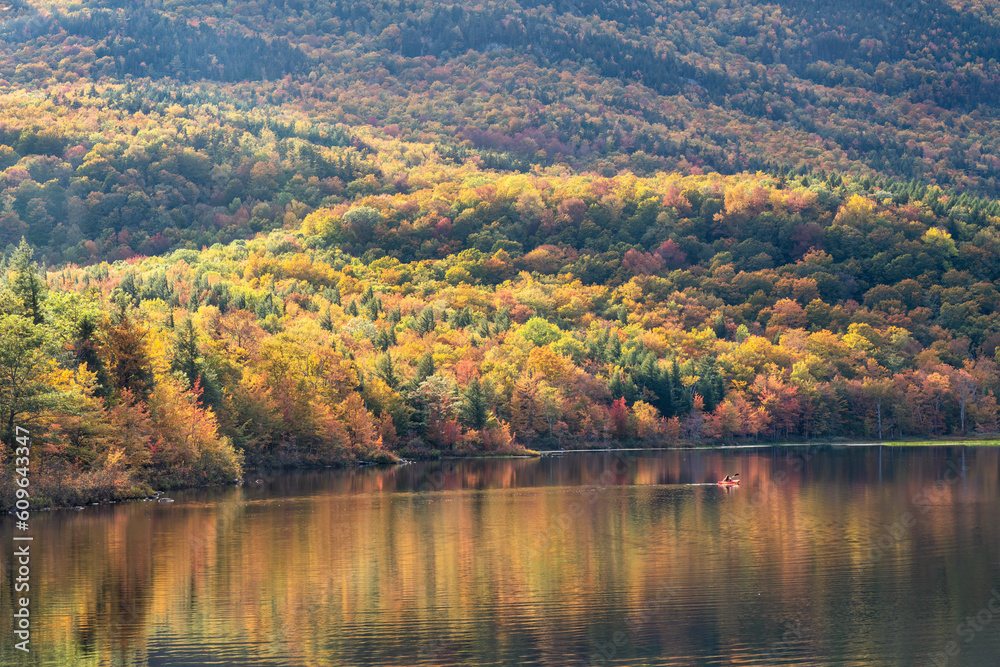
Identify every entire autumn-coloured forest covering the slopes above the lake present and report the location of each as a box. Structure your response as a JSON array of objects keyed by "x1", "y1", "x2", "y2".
[{"x1": 0, "y1": 0, "x2": 1000, "y2": 503}]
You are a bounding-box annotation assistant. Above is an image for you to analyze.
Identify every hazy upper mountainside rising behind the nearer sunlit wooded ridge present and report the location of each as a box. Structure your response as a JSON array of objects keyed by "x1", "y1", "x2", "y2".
[{"x1": 0, "y1": 0, "x2": 1000, "y2": 264}]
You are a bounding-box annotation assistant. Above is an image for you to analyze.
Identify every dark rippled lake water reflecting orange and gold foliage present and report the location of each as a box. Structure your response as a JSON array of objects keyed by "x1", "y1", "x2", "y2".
[{"x1": 0, "y1": 447, "x2": 1000, "y2": 667}]
